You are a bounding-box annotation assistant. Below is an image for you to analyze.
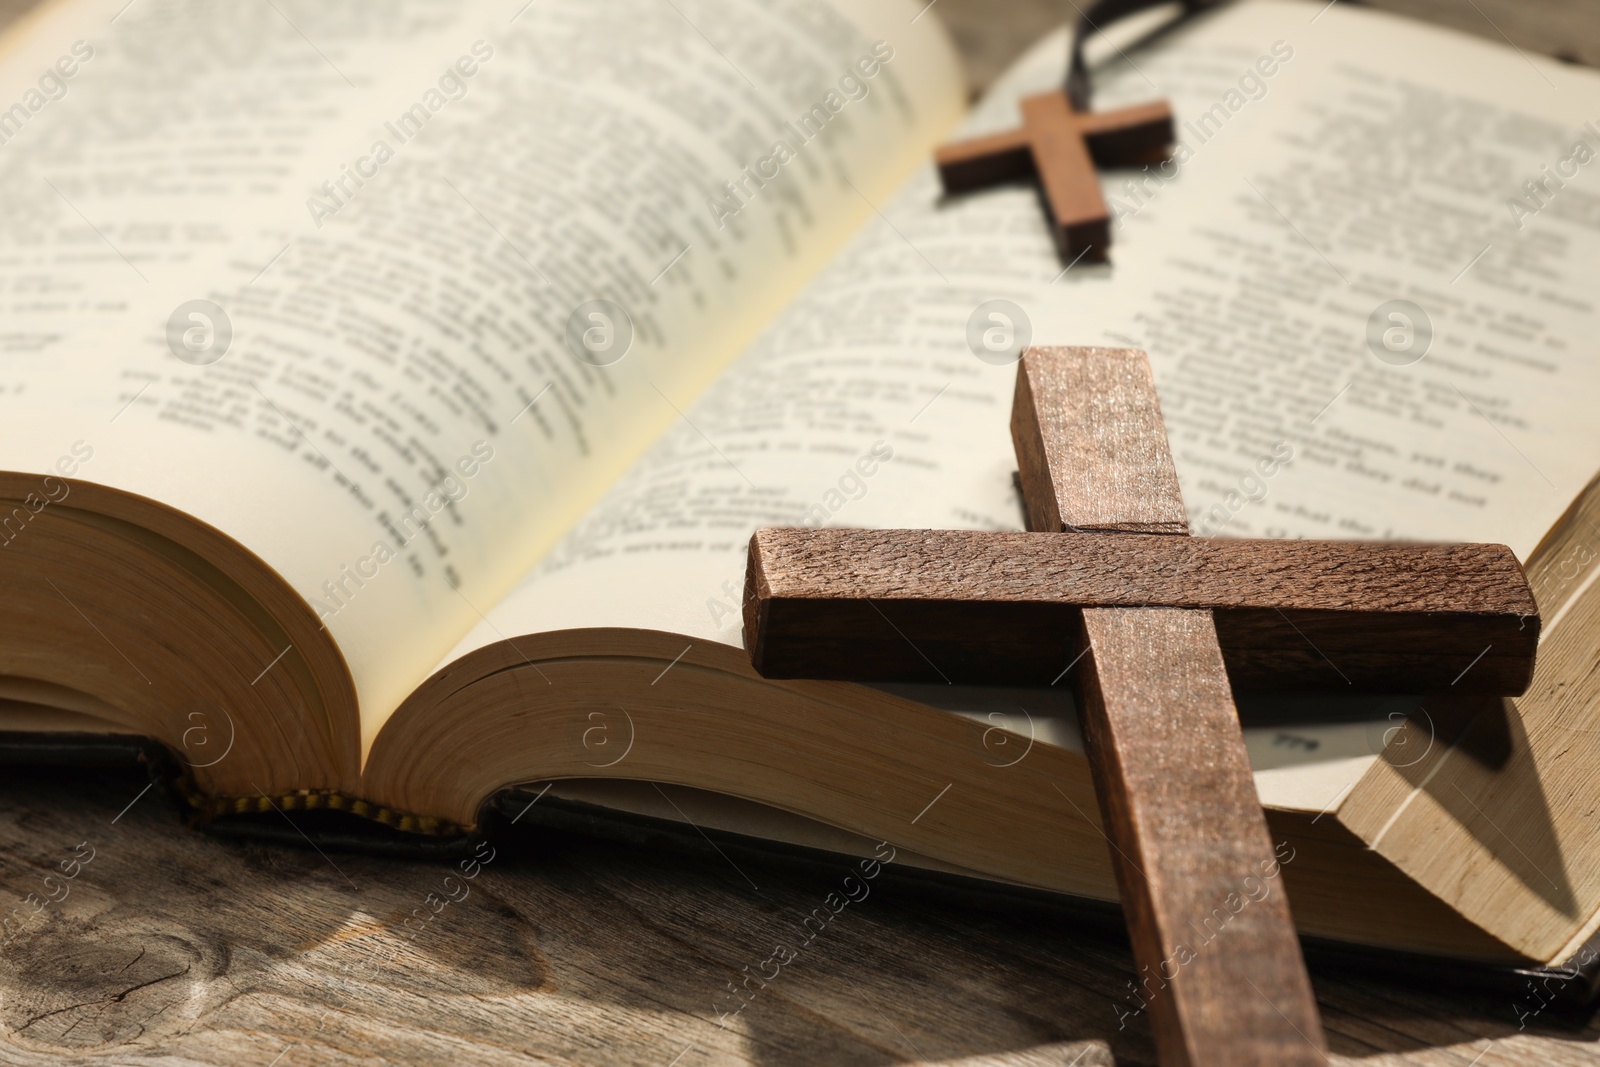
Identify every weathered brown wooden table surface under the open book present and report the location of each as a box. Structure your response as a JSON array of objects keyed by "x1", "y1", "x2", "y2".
[{"x1": 0, "y1": 0, "x2": 1600, "y2": 1067}]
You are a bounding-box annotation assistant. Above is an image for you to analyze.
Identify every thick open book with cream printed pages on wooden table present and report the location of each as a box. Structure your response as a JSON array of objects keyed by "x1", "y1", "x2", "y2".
[{"x1": 0, "y1": 0, "x2": 1600, "y2": 991}]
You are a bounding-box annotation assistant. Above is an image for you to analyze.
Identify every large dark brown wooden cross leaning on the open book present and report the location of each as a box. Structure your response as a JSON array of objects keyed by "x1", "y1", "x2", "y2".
[{"x1": 744, "y1": 349, "x2": 1539, "y2": 1067}]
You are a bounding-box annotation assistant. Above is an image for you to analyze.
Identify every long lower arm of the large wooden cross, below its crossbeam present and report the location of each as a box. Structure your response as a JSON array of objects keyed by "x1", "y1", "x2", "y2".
[{"x1": 1078, "y1": 608, "x2": 1328, "y2": 1067}]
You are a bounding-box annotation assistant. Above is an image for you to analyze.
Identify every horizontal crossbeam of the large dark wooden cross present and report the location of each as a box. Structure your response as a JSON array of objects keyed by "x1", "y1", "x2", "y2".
[{"x1": 744, "y1": 530, "x2": 1539, "y2": 696}]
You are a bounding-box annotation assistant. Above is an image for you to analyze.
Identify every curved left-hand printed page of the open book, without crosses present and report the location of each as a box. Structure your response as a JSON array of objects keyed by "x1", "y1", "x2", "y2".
[{"x1": 0, "y1": 0, "x2": 962, "y2": 751}]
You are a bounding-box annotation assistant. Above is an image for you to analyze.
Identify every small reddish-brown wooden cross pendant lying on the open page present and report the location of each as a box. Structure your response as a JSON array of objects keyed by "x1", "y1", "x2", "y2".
[{"x1": 934, "y1": 91, "x2": 1173, "y2": 262}]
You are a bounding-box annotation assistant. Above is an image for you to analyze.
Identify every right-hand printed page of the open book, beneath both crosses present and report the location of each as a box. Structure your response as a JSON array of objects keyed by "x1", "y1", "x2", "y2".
[{"x1": 458, "y1": 2, "x2": 1600, "y2": 811}]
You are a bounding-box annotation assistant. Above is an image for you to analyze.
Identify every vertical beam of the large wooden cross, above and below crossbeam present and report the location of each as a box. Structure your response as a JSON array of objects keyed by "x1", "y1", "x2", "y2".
[{"x1": 1011, "y1": 349, "x2": 1326, "y2": 1067}]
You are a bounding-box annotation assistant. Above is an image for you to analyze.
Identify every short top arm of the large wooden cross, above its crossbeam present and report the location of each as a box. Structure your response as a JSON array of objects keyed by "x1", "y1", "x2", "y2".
[{"x1": 1011, "y1": 347, "x2": 1189, "y2": 534}]
